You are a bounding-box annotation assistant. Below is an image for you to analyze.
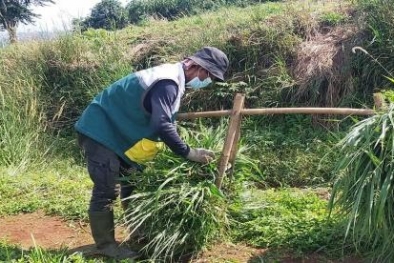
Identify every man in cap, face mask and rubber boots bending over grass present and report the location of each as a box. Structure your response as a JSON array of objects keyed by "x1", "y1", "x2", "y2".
[{"x1": 75, "y1": 47, "x2": 229, "y2": 259}]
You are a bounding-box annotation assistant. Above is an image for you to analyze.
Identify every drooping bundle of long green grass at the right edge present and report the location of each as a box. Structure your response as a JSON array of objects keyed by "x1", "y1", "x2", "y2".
[{"x1": 330, "y1": 104, "x2": 394, "y2": 262}]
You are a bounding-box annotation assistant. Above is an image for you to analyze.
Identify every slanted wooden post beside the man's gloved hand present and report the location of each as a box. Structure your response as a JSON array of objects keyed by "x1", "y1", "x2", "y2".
[{"x1": 215, "y1": 93, "x2": 245, "y2": 188}]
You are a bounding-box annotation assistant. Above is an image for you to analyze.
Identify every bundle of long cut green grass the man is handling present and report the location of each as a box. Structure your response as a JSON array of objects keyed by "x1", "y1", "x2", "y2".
[{"x1": 120, "y1": 121, "x2": 262, "y2": 262}]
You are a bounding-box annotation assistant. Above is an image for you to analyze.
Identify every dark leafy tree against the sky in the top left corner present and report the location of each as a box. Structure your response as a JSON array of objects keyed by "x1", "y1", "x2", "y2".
[{"x1": 0, "y1": 0, "x2": 54, "y2": 43}]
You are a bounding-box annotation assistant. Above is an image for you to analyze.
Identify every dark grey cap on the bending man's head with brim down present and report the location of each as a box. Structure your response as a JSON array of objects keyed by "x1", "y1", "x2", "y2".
[{"x1": 188, "y1": 47, "x2": 229, "y2": 81}]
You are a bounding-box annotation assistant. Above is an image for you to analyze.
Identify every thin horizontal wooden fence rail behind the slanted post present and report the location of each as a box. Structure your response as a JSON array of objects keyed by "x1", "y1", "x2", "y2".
[{"x1": 177, "y1": 108, "x2": 376, "y2": 120}]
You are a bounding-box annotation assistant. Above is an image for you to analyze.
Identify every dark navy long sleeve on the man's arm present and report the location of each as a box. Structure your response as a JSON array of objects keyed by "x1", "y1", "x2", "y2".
[{"x1": 144, "y1": 80, "x2": 190, "y2": 157}]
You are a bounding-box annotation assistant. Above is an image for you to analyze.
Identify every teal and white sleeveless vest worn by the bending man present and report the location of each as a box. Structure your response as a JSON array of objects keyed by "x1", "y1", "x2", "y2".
[{"x1": 75, "y1": 63, "x2": 185, "y2": 163}]
